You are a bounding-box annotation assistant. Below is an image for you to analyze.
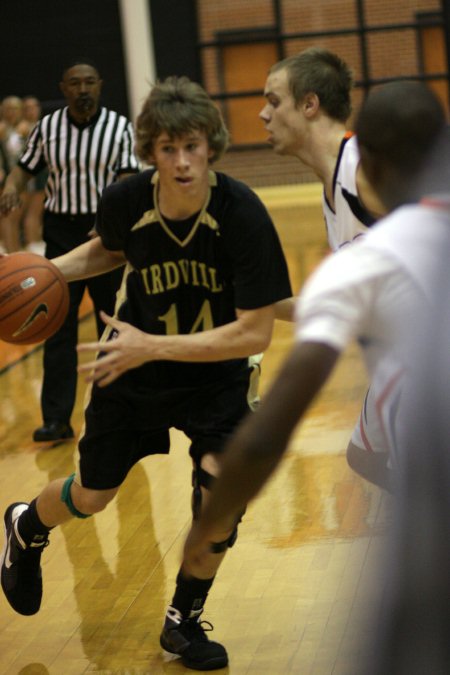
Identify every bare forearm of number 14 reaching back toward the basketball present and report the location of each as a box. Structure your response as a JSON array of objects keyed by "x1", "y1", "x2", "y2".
[{"x1": 52, "y1": 237, "x2": 126, "y2": 281}]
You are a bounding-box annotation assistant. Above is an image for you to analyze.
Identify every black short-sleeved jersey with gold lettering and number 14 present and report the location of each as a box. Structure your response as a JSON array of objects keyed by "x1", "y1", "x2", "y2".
[{"x1": 97, "y1": 170, "x2": 292, "y2": 388}]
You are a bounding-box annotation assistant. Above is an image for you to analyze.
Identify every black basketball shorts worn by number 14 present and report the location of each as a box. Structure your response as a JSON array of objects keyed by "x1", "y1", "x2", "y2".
[{"x1": 77, "y1": 367, "x2": 252, "y2": 490}]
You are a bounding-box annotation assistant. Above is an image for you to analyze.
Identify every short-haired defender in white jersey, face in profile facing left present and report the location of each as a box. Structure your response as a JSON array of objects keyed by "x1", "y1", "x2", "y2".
[{"x1": 260, "y1": 47, "x2": 396, "y2": 488}]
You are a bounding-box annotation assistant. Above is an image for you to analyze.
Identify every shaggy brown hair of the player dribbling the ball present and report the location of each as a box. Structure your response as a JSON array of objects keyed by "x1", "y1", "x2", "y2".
[{"x1": 136, "y1": 76, "x2": 229, "y2": 163}]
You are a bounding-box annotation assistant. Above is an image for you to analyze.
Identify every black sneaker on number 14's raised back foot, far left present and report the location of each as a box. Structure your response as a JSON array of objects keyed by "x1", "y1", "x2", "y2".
[{"x1": 0, "y1": 502, "x2": 48, "y2": 616}]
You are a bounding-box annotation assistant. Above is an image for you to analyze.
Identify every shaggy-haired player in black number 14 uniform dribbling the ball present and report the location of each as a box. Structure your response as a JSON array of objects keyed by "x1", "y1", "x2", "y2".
[{"x1": 2, "y1": 78, "x2": 291, "y2": 670}]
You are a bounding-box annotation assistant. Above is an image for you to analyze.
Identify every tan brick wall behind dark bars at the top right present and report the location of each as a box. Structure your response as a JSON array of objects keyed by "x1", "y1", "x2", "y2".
[{"x1": 197, "y1": 0, "x2": 441, "y2": 93}]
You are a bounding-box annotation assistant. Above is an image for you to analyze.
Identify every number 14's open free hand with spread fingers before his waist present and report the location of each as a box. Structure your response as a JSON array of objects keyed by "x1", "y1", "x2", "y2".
[{"x1": 77, "y1": 312, "x2": 150, "y2": 387}]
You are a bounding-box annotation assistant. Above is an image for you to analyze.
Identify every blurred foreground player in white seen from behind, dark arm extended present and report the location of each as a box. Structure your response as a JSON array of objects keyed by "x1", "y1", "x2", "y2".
[{"x1": 185, "y1": 82, "x2": 450, "y2": 573}]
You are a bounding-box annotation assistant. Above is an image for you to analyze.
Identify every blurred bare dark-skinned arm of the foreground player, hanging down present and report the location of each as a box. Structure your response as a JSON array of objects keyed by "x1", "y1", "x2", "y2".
[{"x1": 185, "y1": 342, "x2": 339, "y2": 570}]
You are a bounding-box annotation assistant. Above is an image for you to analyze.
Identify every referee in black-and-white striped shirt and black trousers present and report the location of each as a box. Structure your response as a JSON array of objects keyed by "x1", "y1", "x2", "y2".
[{"x1": 0, "y1": 60, "x2": 139, "y2": 442}]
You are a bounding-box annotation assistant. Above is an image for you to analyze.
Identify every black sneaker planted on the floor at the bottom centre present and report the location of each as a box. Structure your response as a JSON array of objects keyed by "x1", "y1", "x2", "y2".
[{"x1": 159, "y1": 607, "x2": 228, "y2": 670}]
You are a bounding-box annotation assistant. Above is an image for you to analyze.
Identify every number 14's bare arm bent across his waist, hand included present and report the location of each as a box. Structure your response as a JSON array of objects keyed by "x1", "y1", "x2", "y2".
[{"x1": 78, "y1": 305, "x2": 275, "y2": 386}]
